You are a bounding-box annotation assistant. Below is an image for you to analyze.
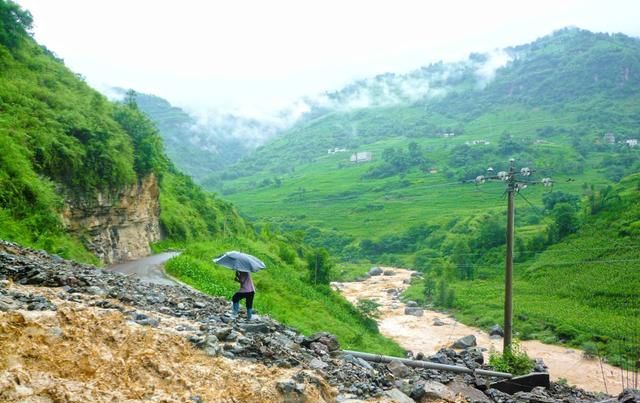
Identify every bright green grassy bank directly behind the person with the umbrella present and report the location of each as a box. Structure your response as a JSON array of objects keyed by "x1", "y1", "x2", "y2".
[{"x1": 166, "y1": 238, "x2": 403, "y2": 356}]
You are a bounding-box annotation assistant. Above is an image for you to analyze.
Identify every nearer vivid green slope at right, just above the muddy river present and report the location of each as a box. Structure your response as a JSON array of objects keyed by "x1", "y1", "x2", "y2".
[{"x1": 405, "y1": 174, "x2": 640, "y2": 365}]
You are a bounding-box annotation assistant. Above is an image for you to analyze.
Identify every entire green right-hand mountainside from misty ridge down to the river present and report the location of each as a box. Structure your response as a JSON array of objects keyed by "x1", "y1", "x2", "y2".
[{"x1": 182, "y1": 29, "x2": 640, "y2": 364}]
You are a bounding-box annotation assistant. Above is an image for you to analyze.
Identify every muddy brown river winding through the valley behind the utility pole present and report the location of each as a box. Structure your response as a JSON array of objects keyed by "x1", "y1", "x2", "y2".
[{"x1": 334, "y1": 268, "x2": 622, "y2": 394}]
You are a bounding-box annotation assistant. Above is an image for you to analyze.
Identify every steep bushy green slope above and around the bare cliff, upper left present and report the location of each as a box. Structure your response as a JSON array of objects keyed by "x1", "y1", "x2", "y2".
[{"x1": 0, "y1": 1, "x2": 246, "y2": 260}]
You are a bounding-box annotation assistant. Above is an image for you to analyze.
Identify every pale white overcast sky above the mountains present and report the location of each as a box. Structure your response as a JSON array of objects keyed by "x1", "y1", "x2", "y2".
[{"x1": 17, "y1": 0, "x2": 640, "y2": 118}]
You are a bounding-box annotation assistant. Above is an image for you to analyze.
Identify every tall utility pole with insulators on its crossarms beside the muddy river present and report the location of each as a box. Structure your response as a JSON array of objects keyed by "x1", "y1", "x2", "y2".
[{"x1": 475, "y1": 158, "x2": 553, "y2": 354}]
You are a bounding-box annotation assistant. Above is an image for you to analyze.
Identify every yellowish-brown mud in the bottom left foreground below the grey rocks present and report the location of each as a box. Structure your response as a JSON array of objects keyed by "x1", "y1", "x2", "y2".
[{"x1": 0, "y1": 285, "x2": 332, "y2": 402}]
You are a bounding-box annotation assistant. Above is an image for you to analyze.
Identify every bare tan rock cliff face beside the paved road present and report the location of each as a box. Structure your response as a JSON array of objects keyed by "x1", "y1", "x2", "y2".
[{"x1": 62, "y1": 174, "x2": 161, "y2": 264}]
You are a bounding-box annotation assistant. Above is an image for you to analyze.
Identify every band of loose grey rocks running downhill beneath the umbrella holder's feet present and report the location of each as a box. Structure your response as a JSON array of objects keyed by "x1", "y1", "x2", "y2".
[{"x1": 0, "y1": 241, "x2": 632, "y2": 403}]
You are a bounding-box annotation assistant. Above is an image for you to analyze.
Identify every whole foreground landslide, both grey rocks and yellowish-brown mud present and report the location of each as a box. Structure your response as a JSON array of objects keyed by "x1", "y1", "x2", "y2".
[{"x1": 0, "y1": 241, "x2": 632, "y2": 403}]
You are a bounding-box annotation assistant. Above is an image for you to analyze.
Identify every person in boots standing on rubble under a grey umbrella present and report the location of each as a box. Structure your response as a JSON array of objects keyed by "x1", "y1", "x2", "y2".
[{"x1": 213, "y1": 251, "x2": 266, "y2": 320}]
